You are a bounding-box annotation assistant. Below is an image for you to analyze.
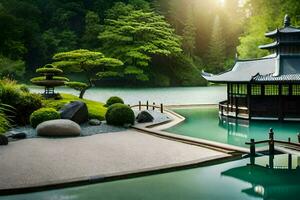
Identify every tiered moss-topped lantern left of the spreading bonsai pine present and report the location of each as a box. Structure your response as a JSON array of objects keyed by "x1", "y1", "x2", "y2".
[{"x1": 30, "y1": 64, "x2": 69, "y2": 98}]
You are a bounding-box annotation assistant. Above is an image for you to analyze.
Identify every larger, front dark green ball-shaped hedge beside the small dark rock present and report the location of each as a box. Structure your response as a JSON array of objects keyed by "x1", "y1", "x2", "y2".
[{"x1": 105, "y1": 103, "x2": 135, "y2": 126}]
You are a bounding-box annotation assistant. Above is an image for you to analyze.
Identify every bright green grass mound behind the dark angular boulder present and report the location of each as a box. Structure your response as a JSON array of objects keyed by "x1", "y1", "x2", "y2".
[{"x1": 43, "y1": 93, "x2": 107, "y2": 120}]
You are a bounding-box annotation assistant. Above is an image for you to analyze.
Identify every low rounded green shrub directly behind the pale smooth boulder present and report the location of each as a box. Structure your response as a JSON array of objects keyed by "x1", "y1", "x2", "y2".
[{"x1": 30, "y1": 108, "x2": 60, "y2": 128}]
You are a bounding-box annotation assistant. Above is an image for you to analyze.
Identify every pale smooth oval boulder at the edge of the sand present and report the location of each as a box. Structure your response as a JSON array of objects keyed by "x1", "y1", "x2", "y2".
[{"x1": 36, "y1": 119, "x2": 81, "y2": 137}]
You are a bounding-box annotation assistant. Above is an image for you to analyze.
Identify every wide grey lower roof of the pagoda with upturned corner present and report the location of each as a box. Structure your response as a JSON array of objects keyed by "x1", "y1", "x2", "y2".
[{"x1": 202, "y1": 56, "x2": 300, "y2": 83}]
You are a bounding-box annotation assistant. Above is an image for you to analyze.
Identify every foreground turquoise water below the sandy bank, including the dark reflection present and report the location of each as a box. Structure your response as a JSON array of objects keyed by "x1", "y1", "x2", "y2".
[{"x1": 0, "y1": 155, "x2": 300, "y2": 200}]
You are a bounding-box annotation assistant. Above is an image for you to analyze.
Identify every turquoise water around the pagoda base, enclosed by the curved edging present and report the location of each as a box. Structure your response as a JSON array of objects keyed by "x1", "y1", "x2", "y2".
[{"x1": 167, "y1": 108, "x2": 300, "y2": 147}]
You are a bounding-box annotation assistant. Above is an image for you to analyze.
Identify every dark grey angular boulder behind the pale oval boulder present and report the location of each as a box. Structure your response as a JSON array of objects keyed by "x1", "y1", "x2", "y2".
[{"x1": 59, "y1": 101, "x2": 89, "y2": 124}]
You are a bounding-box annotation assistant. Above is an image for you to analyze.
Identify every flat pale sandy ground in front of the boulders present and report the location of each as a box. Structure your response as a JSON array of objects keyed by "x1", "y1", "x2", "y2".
[{"x1": 0, "y1": 130, "x2": 229, "y2": 190}]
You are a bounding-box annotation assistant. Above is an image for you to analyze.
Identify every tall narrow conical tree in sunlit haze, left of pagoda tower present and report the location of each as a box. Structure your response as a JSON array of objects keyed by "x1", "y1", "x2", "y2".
[{"x1": 206, "y1": 16, "x2": 226, "y2": 73}]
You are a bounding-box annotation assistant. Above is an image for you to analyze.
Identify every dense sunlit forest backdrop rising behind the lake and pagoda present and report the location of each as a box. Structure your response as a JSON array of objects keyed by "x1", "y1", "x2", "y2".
[{"x1": 0, "y1": 0, "x2": 300, "y2": 86}]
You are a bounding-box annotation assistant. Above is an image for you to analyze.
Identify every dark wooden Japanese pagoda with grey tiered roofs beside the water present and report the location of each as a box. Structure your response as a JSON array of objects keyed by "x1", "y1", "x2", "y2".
[{"x1": 202, "y1": 15, "x2": 300, "y2": 120}]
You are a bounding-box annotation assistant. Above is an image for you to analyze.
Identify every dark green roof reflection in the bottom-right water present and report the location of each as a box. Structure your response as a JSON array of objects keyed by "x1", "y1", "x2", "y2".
[{"x1": 221, "y1": 154, "x2": 300, "y2": 199}]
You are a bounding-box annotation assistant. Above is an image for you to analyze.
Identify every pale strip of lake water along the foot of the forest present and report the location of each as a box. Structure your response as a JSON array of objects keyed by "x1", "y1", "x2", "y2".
[{"x1": 30, "y1": 86, "x2": 226, "y2": 105}]
